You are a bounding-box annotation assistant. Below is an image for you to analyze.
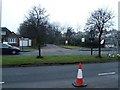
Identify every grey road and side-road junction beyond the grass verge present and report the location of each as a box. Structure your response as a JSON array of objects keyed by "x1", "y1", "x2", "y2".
[{"x1": 20, "y1": 44, "x2": 116, "y2": 56}]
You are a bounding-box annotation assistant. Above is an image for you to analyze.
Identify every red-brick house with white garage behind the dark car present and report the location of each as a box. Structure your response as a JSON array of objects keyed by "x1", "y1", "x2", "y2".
[{"x1": 1, "y1": 27, "x2": 32, "y2": 47}]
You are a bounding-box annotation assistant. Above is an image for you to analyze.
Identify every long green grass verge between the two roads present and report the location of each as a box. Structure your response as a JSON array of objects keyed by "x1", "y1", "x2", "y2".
[{"x1": 0, "y1": 55, "x2": 116, "y2": 66}]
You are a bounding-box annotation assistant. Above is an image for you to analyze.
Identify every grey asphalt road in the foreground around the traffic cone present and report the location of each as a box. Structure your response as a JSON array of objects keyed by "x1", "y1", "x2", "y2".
[{"x1": 2, "y1": 62, "x2": 118, "y2": 88}]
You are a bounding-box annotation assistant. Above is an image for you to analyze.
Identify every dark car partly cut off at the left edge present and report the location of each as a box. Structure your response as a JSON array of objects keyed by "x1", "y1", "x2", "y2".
[{"x1": 0, "y1": 43, "x2": 20, "y2": 55}]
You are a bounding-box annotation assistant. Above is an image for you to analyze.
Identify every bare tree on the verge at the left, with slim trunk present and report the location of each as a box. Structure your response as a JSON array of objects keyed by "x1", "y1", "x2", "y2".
[{"x1": 26, "y1": 5, "x2": 48, "y2": 58}]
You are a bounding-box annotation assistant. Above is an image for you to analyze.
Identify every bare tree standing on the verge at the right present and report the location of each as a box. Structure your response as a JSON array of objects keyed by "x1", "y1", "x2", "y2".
[{"x1": 86, "y1": 8, "x2": 114, "y2": 58}]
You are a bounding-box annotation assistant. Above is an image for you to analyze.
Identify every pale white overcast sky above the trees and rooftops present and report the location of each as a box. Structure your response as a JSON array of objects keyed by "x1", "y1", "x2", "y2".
[{"x1": 1, "y1": 0, "x2": 119, "y2": 32}]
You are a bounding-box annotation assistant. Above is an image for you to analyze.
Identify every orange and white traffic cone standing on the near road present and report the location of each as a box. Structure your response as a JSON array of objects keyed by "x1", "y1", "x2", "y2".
[{"x1": 72, "y1": 63, "x2": 87, "y2": 87}]
